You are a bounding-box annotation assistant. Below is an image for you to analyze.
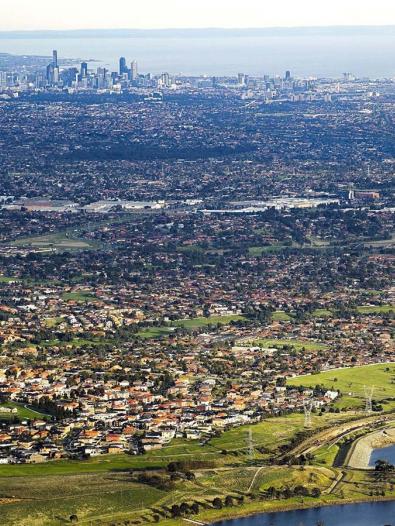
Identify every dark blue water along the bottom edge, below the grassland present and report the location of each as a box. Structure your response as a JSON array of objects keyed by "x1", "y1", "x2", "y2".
[{"x1": 216, "y1": 501, "x2": 395, "y2": 526}]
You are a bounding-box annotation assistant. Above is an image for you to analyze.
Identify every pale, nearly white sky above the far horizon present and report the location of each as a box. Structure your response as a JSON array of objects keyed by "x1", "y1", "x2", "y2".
[{"x1": 0, "y1": 0, "x2": 395, "y2": 30}]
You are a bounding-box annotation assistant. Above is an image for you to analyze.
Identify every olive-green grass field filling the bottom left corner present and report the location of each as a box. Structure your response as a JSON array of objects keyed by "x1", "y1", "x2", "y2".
[{"x1": 0, "y1": 474, "x2": 165, "y2": 526}]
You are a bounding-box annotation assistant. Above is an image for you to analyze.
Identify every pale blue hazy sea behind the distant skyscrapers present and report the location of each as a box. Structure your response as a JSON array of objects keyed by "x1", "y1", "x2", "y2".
[{"x1": 0, "y1": 32, "x2": 395, "y2": 78}]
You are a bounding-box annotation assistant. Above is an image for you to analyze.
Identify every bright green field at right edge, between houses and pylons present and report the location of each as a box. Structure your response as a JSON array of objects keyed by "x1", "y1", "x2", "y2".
[{"x1": 288, "y1": 363, "x2": 395, "y2": 408}]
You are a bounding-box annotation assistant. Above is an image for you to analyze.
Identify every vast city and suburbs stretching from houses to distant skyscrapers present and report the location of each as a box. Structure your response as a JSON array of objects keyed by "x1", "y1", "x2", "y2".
[{"x1": 0, "y1": 51, "x2": 395, "y2": 470}]
